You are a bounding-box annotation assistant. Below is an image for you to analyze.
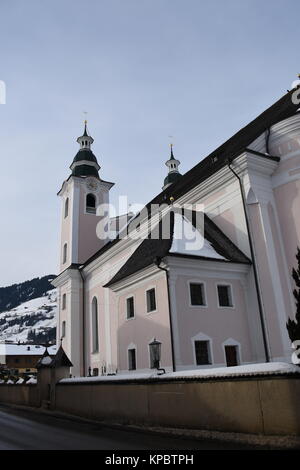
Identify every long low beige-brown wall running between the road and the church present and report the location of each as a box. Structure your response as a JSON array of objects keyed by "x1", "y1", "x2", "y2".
[{"x1": 0, "y1": 375, "x2": 300, "y2": 435}]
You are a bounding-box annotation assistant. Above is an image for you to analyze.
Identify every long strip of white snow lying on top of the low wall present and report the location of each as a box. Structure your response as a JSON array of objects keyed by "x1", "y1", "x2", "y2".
[{"x1": 60, "y1": 362, "x2": 300, "y2": 383}]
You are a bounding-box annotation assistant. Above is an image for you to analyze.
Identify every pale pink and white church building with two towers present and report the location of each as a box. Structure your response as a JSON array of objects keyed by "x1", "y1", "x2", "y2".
[{"x1": 53, "y1": 87, "x2": 300, "y2": 376}]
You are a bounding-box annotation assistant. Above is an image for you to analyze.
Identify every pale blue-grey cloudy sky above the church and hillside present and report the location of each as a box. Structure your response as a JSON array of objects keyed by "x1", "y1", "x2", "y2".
[{"x1": 0, "y1": 0, "x2": 300, "y2": 286}]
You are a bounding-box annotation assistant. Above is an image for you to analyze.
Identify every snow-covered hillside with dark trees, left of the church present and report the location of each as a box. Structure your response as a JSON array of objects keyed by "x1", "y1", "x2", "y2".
[{"x1": 0, "y1": 289, "x2": 57, "y2": 343}]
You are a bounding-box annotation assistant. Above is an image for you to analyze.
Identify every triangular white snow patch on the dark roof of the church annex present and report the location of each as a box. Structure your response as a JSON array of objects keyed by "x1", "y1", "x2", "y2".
[{"x1": 169, "y1": 212, "x2": 226, "y2": 259}]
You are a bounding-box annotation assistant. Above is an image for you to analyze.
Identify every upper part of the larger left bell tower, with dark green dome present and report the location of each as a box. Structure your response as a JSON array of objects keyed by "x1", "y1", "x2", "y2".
[{"x1": 58, "y1": 121, "x2": 114, "y2": 272}]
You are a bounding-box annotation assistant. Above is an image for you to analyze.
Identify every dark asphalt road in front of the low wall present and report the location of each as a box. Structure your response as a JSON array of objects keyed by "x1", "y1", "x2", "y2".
[{"x1": 0, "y1": 406, "x2": 262, "y2": 450}]
